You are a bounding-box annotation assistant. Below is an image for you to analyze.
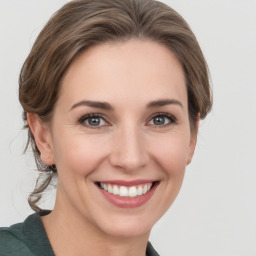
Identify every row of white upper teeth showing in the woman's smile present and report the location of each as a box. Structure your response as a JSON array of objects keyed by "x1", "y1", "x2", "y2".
[{"x1": 100, "y1": 183, "x2": 152, "y2": 197}]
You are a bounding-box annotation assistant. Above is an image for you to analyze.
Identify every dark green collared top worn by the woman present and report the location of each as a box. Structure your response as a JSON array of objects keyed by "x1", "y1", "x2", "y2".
[{"x1": 0, "y1": 211, "x2": 159, "y2": 256}]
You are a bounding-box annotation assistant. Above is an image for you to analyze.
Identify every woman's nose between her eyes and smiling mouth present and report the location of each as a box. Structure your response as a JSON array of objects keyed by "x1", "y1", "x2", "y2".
[{"x1": 110, "y1": 124, "x2": 149, "y2": 172}]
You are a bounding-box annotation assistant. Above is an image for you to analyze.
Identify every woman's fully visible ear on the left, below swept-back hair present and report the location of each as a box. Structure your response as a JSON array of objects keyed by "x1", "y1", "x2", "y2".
[{"x1": 27, "y1": 113, "x2": 55, "y2": 165}]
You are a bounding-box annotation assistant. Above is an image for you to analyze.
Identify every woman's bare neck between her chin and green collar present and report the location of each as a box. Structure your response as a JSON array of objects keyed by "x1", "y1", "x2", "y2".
[{"x1": 42, "y1": 187, "x2": 149, "y2": 256}]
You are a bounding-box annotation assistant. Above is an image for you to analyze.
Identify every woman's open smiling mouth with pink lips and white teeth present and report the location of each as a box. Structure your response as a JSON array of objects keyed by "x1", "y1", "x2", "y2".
[{"x1": 96, "y1": 181, "x2": 159, "y2": 208}]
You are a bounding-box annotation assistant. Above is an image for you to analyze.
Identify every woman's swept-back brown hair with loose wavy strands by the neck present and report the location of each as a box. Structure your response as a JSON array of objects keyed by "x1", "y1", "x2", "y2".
[{"x1": 19, "y1": 0, "x2": 212, "y2": 211}]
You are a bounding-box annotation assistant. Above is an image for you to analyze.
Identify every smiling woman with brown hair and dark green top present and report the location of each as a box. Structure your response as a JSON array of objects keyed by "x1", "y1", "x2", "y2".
[{"x1": 0, "y1": 0, "x2": 211, "y2": 256}]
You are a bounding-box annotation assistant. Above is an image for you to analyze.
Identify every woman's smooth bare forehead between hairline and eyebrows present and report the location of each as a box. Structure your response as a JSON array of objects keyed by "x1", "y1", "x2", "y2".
[{"x1": 57, "y1": 39, "x2": 186, "y2": 108}]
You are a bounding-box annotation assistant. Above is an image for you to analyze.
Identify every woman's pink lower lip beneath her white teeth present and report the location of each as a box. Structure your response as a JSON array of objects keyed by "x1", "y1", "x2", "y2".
[{"x1": 99, "y1": 183, "x2": 158, "y2": 208}]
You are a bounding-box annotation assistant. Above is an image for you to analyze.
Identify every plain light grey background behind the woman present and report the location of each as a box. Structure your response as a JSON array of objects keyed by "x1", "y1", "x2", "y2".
[{"x1": 0, "y1": 0, "x2": 256, "y2": 256}]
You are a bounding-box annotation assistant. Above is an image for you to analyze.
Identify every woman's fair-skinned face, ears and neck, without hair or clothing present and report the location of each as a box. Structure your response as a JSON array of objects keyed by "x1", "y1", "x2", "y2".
[{"x1": 28, "y1": 39, "x2": 199, "y2": 256}]
